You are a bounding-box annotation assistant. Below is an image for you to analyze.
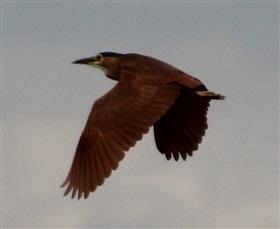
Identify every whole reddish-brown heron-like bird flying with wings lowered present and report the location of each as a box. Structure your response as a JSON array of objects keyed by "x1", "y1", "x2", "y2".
[{"x1": 61, "y1": 52, "x2": 225, "y2": 199}]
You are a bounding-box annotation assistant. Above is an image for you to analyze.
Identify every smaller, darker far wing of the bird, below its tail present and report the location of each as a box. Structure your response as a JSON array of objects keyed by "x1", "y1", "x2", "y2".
[{"x1": 154, "y1": 85, "x2": 210, "y2": 161}]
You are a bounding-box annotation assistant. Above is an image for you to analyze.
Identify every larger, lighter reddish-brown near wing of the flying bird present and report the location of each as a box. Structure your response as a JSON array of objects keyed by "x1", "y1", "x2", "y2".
[{"x1": 62, "y1": 74, "x2": 180, "y2": 198}]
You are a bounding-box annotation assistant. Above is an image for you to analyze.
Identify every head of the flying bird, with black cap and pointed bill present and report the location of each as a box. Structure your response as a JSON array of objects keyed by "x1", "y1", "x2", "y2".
[{"x1": 73, "y1": 52, "x2": 123, "y2": 80}]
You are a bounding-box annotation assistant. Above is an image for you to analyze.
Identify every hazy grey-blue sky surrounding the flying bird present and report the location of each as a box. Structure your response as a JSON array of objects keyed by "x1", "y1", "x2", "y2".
[{"x1": 1, "y1": 1, "x2": 279, "y2": 228}]
